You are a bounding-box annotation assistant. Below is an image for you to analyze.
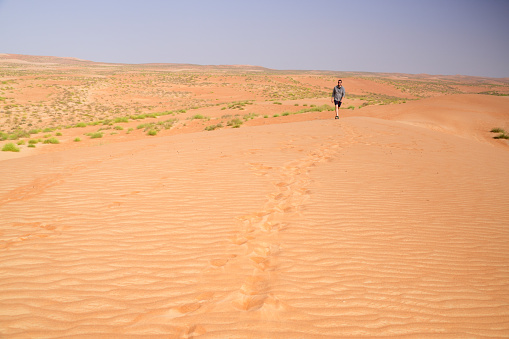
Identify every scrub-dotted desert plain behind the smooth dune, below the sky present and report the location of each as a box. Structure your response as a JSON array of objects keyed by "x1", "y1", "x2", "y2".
[{"x1": 0, "y1": 57, "x2": 509, "y2": 154}]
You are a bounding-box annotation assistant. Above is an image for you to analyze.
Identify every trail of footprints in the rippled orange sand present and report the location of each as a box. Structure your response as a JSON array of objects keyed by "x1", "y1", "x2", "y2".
[{"x1": 200, "y1": 140, "x2": 339, "y2": 311}]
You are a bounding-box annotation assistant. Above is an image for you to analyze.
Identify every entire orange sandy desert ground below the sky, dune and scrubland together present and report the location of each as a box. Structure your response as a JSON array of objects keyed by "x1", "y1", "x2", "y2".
[{"x1": 0, "y1": 54, "x2": 509, "y2": 338}]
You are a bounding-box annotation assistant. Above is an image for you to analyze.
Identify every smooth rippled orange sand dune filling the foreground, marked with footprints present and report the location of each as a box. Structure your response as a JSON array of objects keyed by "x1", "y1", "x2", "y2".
[{"x1": 0, "y1": 54, "x2": 509, "y2": 338}]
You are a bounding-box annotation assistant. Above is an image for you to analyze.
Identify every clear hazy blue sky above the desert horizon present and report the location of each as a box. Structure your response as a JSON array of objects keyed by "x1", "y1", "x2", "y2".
[{"x1": 0, "y1": 0, "x2": 509, "y2": 77}]
